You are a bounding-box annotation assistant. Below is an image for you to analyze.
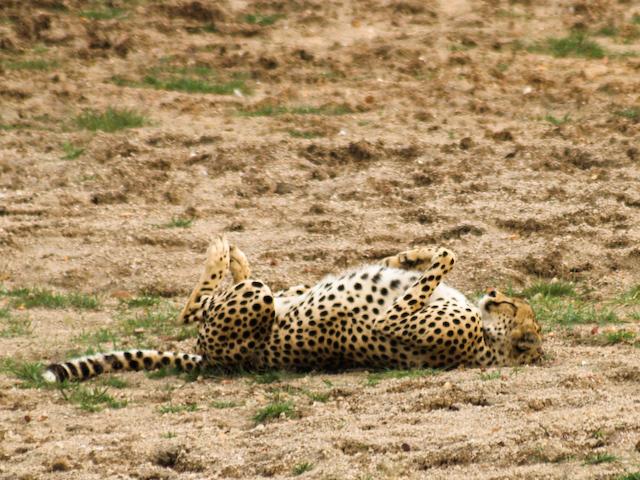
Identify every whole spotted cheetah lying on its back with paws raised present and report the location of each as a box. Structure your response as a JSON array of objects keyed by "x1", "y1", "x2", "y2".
[{"x1": 44, "y1": 237, "x2": 542, "y2": 382}]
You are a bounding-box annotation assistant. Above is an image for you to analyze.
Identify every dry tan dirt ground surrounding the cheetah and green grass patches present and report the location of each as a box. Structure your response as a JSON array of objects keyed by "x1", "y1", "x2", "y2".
[{"x1": 0, "y1": 0, "x2": 640, "y2": 479}]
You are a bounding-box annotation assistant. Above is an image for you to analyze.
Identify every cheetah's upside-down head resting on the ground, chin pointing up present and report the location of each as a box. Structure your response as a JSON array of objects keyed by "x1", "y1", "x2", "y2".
[{"x1": 478, "y1": 289, "x2": 542, "y2": 365}]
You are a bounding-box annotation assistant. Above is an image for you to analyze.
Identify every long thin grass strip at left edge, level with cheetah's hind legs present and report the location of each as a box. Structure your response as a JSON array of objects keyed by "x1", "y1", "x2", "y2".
[{"x1": 0, "y1": 288, "x2": 100, "y2": 310}]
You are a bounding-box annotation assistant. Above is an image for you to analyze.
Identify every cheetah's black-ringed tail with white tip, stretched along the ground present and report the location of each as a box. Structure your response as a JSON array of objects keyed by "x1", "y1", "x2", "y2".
[{"x1": 42, "y1": 350, "x2": 203, "y2": 383}]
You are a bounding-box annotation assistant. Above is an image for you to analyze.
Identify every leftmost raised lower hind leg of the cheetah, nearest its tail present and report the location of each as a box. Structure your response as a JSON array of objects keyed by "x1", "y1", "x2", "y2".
[{"x1": 178, "y1": 236, "x2": 230, "y2": 323}]
